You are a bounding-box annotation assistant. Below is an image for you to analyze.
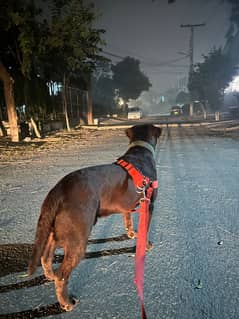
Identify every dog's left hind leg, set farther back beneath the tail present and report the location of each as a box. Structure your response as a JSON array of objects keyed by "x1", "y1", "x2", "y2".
[{"x1": 41, "y1": 232, "x2": 56, "y2": 280}]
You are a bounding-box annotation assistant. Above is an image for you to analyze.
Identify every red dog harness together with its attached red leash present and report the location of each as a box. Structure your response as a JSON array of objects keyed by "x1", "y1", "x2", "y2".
[{"x1": 117, "y1": 159, "x2": 158, "y2": 319}]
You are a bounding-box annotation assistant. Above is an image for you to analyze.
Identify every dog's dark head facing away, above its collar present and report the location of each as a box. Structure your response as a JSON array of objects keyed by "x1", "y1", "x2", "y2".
[{"x1": 125, "y1": 124, "x2": 162, "y2": 147}]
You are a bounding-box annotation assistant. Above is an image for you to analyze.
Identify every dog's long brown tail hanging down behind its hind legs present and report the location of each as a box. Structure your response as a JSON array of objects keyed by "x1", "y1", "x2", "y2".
[{"x1": 28, "y1": 188, "x2": 61, "y2": 276}]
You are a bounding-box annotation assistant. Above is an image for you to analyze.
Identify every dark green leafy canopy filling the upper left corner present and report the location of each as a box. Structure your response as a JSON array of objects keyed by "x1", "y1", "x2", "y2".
[{"x1": 0, "y1": 0, "x2": 104, "y2": 80}]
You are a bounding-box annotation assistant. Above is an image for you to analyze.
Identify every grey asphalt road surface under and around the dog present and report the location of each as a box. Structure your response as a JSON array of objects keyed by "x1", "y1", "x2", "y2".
[{"x1": 0, "y1": 128, "x2": 239, "y2": 319}]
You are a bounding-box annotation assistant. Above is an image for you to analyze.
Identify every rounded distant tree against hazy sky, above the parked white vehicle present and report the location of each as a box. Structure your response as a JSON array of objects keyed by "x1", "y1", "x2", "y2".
[{"x1": 112, "y1": 57, "x2": 151, "y2": 102}]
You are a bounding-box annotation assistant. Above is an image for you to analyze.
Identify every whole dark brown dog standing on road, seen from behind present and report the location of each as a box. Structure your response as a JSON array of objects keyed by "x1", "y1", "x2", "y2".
[{"x1": 28, "y1": 125, "x2": 161, "y2": 311}]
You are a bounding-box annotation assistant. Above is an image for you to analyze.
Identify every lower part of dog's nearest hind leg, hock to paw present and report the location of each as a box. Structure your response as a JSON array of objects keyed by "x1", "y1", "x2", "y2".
[{"x1": 55, "y1": 246, "x2": 85, "y2": 311}]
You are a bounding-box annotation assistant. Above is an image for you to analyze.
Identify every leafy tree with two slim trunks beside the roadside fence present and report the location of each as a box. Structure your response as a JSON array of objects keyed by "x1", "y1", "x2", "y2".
[{"x1": 47, "y1": 0, "x2": 104, "y2": 129}]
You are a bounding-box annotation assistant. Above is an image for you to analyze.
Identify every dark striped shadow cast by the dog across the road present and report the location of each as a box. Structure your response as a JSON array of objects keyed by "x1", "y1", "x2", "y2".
[{"x1": 0, "y1": 235, "x2": 136, "y2": 319}]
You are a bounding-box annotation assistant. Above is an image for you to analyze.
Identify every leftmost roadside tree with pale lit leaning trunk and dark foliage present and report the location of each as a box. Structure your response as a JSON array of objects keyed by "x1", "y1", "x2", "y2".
[{"x1": 0, "y1": 0, "x2": 57, "y2": 141}]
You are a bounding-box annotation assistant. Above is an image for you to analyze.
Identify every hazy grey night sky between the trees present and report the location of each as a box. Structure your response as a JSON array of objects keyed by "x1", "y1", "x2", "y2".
[{"x1": 93, "y1": 0, "x2": 230, "y2": 92}]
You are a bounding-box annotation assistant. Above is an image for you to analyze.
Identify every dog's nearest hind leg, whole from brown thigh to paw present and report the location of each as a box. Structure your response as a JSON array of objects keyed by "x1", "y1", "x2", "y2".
[{"x1": 54, "y1": 202, "x2": 98, "y2": 311}]
